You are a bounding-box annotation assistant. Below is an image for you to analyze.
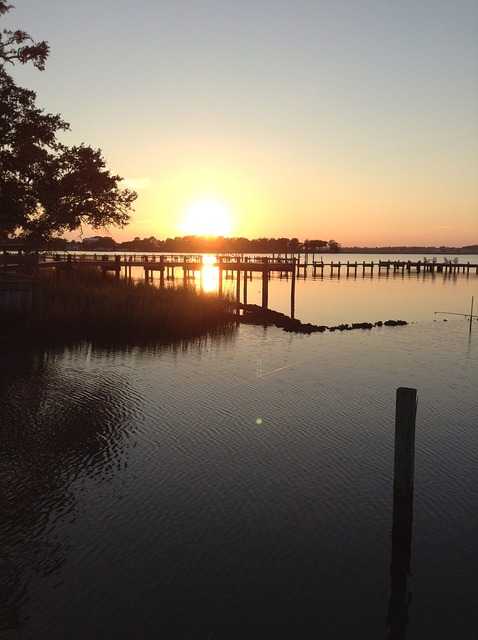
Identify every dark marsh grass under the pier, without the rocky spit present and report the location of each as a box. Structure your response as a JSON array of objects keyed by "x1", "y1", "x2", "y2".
[{"x1": 34, "y1": 269, "x2": 235, "y2": 343}]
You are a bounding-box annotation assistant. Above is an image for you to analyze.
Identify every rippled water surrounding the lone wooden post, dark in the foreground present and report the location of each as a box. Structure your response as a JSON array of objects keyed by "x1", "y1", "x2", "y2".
[{"x1": 0, "y1": 256, "x2": 478, "y2": 640}]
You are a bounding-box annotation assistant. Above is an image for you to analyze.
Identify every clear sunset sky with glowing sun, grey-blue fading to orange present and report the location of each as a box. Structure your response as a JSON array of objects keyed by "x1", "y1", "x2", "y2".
[{"x1": 2, "y1": 0, "x2": 478, "y2": 247}]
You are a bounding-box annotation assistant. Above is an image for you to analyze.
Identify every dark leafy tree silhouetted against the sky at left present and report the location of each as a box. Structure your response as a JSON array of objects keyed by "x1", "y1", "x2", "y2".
[{"x1": 0, "y1": 0, "x2": 137, "y2": 245}]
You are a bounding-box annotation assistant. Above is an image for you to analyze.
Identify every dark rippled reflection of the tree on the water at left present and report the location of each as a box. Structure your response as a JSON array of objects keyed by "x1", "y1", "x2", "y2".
[{"x1": 0, "y1": 349, "x2": 142, "y2": 628}]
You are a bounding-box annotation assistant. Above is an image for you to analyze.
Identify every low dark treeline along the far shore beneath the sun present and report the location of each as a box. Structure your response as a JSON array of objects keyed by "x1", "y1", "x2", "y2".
[{"x1": 40, "y1": 236, "x2": 478, "y2": 255}]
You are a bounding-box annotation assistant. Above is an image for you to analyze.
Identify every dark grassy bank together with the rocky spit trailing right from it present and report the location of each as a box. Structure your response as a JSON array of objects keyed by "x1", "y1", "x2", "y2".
[{"x1": 2, "y1": 269, "x2": 407, "y2": 345}]
